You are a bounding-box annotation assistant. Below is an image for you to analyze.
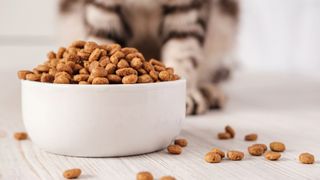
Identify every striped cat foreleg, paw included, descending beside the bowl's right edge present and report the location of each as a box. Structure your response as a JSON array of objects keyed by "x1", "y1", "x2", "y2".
[{"x1": 159, "y1": 0, "x2": 209, "y2": 114}]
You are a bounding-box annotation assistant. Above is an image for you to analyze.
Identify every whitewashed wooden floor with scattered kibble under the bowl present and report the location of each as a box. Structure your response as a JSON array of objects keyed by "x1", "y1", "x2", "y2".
[{"x1": 0, "y1": 73, "x2": 320, "y2": 180}]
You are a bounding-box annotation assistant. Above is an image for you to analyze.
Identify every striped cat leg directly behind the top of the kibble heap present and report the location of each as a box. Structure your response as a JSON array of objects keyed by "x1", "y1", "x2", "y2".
[{"x1": 84, "y1": 0, "x2": 132, "y2": 46}]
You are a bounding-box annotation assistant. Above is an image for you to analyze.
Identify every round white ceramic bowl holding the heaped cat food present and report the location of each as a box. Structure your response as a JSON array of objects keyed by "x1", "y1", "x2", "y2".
[{"x1": 21, "y1": 80, "x2": 186, "y2": 157}]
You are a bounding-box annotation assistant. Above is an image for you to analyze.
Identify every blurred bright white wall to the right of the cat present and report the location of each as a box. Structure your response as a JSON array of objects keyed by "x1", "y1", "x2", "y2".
[{"x1": 238, "y1": 0, "x2": 320, "y2": 73}]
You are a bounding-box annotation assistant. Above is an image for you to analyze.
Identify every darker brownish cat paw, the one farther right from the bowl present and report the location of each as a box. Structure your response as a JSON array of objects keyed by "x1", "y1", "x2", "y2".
[{"x1": 200, "y1": 84, "x2": 227, "y2": 109}]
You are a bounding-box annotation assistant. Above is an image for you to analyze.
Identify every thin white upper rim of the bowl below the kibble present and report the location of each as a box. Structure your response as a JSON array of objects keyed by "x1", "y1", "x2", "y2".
[{"x1": 20, "y1": 79, "x2": 186, "y2": 89}]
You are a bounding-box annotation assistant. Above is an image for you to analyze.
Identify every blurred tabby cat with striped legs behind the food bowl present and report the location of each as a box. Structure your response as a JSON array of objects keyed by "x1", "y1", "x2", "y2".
[{"x1": 59, "y1": 0, "x2": 239, "y2": 114}]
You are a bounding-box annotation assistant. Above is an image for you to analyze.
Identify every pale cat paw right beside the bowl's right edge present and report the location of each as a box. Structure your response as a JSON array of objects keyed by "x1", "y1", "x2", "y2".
[{"x1": 186, "y1": 89, "x2": 208, "y2": 115}]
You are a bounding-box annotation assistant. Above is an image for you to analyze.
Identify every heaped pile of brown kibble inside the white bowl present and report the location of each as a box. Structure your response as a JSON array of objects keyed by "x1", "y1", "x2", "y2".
[{"x1": 18, "y1": 40, "x2": 179, "y2": 84}]
